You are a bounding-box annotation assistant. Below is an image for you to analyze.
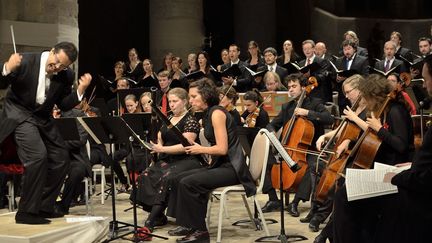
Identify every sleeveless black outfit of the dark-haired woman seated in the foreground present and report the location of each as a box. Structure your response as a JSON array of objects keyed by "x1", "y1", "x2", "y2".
[{"x1": 176, "y1": 106, "x2": 256, "y2": 230}]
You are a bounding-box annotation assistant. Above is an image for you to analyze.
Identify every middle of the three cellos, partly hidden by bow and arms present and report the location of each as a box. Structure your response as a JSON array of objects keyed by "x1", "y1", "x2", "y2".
[{"x1": 315, "y1": 96, "x2": 362, "y2": 202}]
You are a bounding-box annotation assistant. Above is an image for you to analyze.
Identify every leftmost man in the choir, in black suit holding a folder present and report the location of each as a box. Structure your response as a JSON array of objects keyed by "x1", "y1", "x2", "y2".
[{"x1": 221, "y1": 44, "x2": 252, "y2": 93}]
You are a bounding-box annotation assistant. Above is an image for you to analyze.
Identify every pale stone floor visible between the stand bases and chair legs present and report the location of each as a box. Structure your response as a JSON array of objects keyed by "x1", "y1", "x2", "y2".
[{"x1": 0, "y1": 187, "x2": 324, "y2": 243}]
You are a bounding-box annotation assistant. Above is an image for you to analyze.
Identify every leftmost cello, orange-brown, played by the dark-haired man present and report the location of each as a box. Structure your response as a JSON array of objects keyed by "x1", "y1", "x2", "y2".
[{"x1": 271, "y1": 77, "x2": 318, "y2": 190}]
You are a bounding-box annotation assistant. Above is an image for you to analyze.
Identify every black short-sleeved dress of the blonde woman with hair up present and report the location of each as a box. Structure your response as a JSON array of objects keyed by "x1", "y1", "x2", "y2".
[{"x1": 135, "y1": 113, "x2": 201, "y2": 213}]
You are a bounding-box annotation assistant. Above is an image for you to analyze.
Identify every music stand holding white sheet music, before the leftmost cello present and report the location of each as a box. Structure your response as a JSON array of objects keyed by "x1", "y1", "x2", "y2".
[{"x1": 255, "y1": 129, "x2": 308, "y2": 243}]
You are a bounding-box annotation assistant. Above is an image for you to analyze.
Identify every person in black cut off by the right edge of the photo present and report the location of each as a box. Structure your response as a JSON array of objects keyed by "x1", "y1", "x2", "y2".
[{"x1": 376, "y1": 56, "x2": 432, "y2": 243}]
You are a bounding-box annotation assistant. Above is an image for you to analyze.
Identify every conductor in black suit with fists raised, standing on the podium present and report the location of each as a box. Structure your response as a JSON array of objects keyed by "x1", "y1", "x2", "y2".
[{"x1": 0, "y1": 42, "x2": 91, "y2": 224}]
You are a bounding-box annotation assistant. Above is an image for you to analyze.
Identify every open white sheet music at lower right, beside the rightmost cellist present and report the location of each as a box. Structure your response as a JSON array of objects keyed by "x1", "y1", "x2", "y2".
[{"x1": 345, "y1": 162, "x2": 410, "y2": 201}]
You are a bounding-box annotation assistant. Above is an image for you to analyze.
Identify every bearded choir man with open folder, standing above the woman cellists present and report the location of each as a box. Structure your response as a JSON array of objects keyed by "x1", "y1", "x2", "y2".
[{"x1": 334, "y1": 40, "x2": 369, "y2": 112}]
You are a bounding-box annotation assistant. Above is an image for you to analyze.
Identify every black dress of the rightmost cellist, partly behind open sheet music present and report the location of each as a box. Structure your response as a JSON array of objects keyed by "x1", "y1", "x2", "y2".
[{"x1": 333, "y1": 102, "x2": 414, "y2": 242}]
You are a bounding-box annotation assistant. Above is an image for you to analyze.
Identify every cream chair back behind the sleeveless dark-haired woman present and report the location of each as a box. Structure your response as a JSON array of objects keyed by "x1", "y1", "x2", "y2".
[{"x1": 249, "y1": 129, "x2": 270, "y2": 181}]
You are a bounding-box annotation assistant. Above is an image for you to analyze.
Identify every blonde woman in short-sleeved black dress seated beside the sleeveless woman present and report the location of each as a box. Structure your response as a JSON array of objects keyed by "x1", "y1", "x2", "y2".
[{"x1": 137, "y1": 88, "x2": 201, "y2": 234}]
